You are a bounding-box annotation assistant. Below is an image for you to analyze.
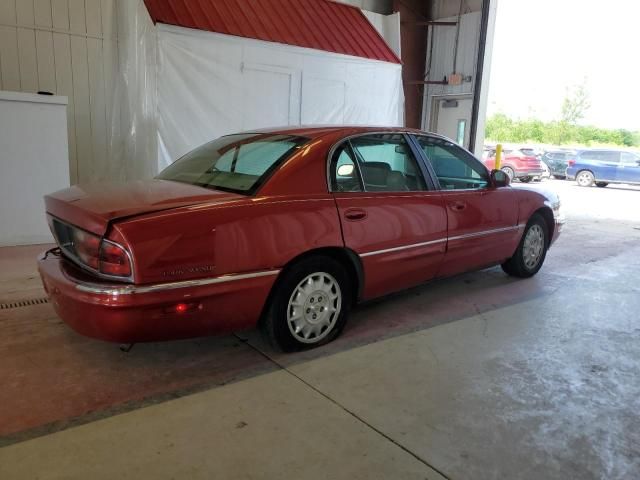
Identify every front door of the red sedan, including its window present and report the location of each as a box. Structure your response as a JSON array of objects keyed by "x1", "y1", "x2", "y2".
[{"x1": 414, "y1": 135, "x2": 524, "y2": 276}]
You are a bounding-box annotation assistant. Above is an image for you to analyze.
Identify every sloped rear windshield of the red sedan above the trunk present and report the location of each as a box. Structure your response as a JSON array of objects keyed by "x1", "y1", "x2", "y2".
[{"x1": 156, "y1": 133, "x2": 308, "y2": 195}]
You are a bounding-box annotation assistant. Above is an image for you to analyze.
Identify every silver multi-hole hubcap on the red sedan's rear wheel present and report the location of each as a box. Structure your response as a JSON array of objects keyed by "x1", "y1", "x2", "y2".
[{"x1": 287, "y1": 272, "x2": 342, "y2": 343}]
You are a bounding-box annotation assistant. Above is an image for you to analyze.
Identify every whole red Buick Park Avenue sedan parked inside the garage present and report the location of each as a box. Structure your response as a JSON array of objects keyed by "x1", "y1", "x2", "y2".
[{"x1": 39, "y1": 127, "x2": 562, "y2": 351}]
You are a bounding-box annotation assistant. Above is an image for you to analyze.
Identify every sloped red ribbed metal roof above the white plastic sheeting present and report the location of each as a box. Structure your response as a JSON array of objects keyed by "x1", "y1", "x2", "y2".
[{"x1": 145, "y1": 0, "x2": 401, "y2": 63}]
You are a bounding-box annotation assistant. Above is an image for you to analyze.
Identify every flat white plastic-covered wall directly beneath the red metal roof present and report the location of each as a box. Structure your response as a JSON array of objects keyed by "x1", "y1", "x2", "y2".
[{"x1": 157, "y1": 25, "x2": 404, "y2": 168}]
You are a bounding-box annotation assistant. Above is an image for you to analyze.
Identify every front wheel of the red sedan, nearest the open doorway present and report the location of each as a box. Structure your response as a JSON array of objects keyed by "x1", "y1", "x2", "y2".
[{"x1": 502, "y1": 213, "x2": 549, "y2": 278}]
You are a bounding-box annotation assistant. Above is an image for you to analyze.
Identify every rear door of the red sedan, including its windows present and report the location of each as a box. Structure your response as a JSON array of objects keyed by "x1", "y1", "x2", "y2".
[{"x1": 329, "y1": 133, "x2": 447, "y2": 299}]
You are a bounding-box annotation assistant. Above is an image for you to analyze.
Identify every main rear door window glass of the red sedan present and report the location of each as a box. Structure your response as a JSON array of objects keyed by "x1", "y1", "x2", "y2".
[{"x1": 350, "y1": 133, "x2": 427, "y2": 192}]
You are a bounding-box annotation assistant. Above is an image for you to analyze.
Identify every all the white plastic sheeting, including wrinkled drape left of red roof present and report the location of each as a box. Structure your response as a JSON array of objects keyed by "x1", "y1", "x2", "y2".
[{"x1": 114, "y1": 1, "x2": 404, "y2": 175}]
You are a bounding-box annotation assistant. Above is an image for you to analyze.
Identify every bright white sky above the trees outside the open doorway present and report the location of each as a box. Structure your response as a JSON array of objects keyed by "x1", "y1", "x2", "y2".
[{"x1": 488, "y1": 0, "x2": 640, "y2": 130}]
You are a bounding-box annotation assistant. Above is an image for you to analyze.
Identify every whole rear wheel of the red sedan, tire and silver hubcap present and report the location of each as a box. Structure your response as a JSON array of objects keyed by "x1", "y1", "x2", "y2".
[{"x1": 262, "y1": 256, "x2": 352, "y2": 352}]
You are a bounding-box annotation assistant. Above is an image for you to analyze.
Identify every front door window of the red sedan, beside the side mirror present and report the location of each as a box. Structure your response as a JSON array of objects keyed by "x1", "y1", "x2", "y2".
[{"x1": 416, "y1": 136, "x2": 489, "y2": 190}]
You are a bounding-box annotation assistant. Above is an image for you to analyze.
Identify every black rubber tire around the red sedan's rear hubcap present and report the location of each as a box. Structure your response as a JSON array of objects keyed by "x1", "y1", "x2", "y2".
[{"x1": 261, "y1": 255, "x2": 353, "y2": 352}]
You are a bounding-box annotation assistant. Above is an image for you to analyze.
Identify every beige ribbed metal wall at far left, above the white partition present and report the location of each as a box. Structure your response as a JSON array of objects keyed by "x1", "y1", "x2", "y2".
[{"x1": 0, "y1": 0, "x2": 118, "y2": 183}]
